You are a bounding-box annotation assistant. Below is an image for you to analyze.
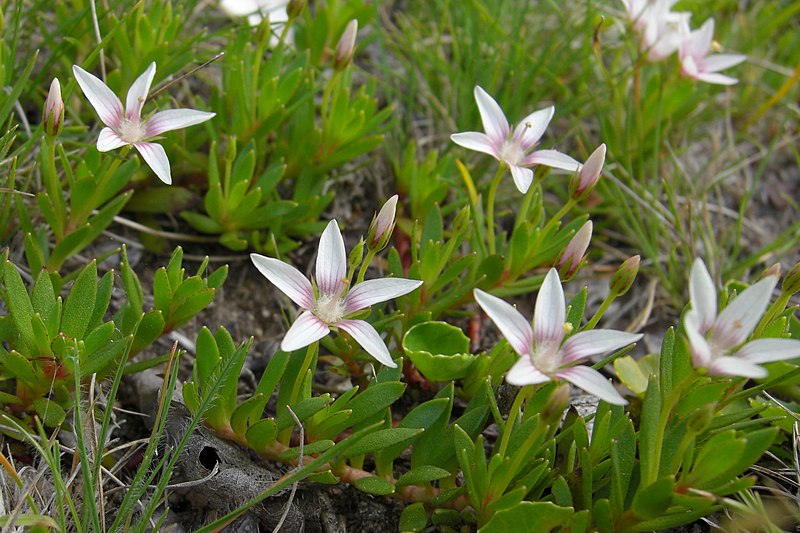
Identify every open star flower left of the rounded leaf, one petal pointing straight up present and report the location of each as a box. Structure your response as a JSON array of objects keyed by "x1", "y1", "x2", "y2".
[{"x1": 250, "y1": 220, "x2": 422, "y2": 367}]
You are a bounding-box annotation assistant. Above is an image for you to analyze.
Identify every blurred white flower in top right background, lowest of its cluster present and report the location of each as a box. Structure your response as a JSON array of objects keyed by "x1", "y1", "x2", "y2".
[{"x1": 679, "y1": 19, "x2": 747, "y2": 85}]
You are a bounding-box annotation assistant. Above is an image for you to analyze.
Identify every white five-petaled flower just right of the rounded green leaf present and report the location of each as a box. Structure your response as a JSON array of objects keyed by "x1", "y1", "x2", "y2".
[{"x1": 474, "y1": 269, "x2": 642, "y2": 405}]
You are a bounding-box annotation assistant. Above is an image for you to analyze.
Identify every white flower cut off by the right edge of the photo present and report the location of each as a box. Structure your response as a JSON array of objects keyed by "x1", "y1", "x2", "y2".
[{"x1": 683, "y1": 259, "x2": 800, "y2": 378}]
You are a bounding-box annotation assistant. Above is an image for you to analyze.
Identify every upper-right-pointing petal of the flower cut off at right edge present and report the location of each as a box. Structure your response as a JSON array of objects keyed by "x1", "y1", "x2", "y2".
[{"x1": 711, "y1": 276, "x2": 778, "y2": 350}]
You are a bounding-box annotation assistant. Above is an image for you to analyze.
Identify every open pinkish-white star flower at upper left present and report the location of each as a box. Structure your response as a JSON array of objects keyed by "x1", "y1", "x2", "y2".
[{"x1": 72, "y1": 63, "x2": 215, "y2": 184}]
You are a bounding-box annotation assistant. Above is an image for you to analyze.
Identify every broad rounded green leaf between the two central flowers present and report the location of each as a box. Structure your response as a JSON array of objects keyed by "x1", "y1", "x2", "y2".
[{"x1": 403, "y1": 322, "x2": 478, "y2": 381}]
